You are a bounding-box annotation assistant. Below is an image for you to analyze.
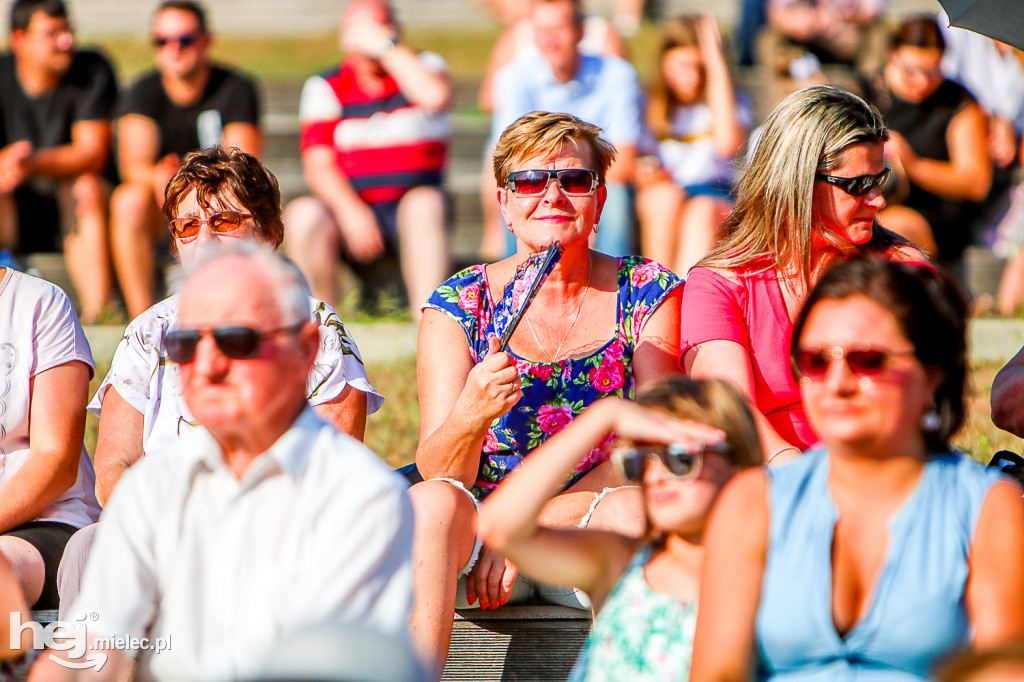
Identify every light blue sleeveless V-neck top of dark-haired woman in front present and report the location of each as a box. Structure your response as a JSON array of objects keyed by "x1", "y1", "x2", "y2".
[{"x1": 757, "y1": 450, "x2": 999, "y2": 682}]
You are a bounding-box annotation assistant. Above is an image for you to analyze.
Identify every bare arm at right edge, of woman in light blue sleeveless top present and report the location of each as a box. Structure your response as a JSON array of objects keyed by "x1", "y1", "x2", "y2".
[{"x1": 967, "y1": 480, "x2": 1024, "y2": 650}]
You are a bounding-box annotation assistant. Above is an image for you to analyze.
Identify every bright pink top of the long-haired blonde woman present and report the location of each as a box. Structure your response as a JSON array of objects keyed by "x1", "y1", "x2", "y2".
[{"x1": 681, "y1": 267, "x2": 818, "y2": 450}]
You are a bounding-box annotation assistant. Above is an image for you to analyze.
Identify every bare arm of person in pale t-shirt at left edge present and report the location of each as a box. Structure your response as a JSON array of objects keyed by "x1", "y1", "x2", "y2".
[{"x1": 0, "y1": 360, "x2": 90, "y2": 531}]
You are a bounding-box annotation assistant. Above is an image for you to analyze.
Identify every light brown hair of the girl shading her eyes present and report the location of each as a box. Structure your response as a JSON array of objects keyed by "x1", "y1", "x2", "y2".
[{"x1": 636, "y1": 374, "x2": 764, "y2": 469}]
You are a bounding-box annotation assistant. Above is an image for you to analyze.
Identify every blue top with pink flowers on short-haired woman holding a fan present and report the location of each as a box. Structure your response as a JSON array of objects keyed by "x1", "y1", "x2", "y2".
[{"x1": 426, "y1": 256, "x2": 682, "y2": 493}]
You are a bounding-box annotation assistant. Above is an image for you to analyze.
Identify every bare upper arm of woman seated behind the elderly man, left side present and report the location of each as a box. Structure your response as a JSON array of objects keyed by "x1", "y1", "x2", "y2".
[{"x1": 92, "y1": 386, "x2": 145, "y2": 507}]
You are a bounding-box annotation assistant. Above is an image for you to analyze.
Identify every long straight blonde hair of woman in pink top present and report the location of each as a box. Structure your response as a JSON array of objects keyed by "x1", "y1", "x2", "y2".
[{"x1": 698, "y1": 85, "x2": 889, "y2": 286}]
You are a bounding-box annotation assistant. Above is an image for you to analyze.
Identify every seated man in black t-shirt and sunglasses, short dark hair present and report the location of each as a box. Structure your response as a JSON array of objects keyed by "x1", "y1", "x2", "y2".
[{"x1": 111, "y1": 0, "x2": 262, "y2": 317}]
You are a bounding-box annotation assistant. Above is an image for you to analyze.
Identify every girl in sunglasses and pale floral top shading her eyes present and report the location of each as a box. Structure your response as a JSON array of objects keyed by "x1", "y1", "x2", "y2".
[{"x1": 479, "y1": 376, "x2": 762, "y2": 682}]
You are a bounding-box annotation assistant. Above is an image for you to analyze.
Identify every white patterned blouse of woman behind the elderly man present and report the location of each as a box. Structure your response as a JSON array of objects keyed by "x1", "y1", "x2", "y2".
[{"x1": 89, "y1": 294, "x2": 384, "y2": 453}]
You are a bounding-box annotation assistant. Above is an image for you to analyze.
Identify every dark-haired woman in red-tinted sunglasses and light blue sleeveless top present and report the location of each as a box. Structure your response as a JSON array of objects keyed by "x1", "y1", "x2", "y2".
[{"x1": 691, "y1": 260, "x2": 1024, "y2": 681}]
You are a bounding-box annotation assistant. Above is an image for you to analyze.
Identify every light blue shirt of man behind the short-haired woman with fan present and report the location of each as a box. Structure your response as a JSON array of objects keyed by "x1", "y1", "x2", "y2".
[{"x1": 490, "y1": 51, "x2": 643, "y2": 146}]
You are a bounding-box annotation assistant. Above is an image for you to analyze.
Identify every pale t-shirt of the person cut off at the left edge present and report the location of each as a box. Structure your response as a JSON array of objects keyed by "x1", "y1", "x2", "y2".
[{"x1": 0, "y1": 268, "x2": 99, "y2": 527}]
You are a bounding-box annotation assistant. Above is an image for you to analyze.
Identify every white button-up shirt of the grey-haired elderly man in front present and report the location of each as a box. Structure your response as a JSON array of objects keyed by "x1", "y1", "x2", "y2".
[{"x1": 72, "y1": 409, "x2": 413, "y2": 680}]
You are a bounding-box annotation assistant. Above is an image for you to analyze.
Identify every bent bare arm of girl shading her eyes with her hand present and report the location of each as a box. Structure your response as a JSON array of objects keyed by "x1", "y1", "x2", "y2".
[{"x1": 477, "y1": 398, "x2": 724, "y2": 609}]
